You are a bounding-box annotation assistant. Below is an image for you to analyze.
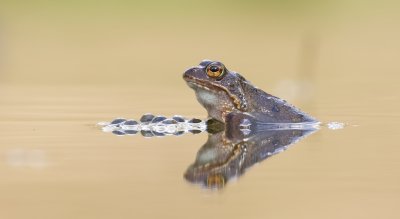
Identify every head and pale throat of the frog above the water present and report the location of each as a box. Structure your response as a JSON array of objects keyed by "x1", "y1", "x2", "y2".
[{"x1": 183, "y1": 60, "x2": 247, "y2": 121}]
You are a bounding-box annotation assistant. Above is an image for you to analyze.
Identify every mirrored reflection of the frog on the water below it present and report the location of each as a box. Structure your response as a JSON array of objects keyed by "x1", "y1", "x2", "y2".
[{"x1": 184, "y1": 119, "x2": 317, "y2": 189}]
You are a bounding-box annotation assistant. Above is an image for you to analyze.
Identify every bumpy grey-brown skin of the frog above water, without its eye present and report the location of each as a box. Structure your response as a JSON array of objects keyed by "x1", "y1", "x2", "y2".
[{"x1": 183, "y1": 60, "x2": 317, "y2": 123}]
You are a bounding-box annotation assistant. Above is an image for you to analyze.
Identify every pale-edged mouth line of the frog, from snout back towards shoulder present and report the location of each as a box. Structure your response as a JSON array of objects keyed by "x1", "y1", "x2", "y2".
[{"x1": 185, "y1": 76, "x2": 241, "y2": 110}]
